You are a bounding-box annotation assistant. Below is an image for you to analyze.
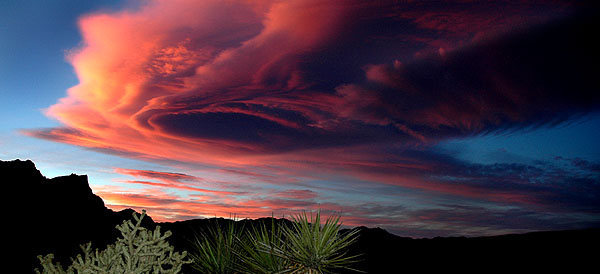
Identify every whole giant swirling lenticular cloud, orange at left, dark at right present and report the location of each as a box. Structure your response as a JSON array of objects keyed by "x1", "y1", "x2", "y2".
[{"x1": 29, "y1": 0, "x2": 599, "y2": 164}]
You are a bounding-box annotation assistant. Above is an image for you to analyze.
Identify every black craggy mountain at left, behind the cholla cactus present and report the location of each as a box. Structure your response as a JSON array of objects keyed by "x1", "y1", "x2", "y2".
[{"x1": 0, "y1": 159, "x2": 148, "y2": 272}]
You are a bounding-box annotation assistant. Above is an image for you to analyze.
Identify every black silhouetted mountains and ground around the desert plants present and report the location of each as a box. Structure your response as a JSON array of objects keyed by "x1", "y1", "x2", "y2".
[{"x1": 0, "y1": 160, "x2": 600, "y2": 273}]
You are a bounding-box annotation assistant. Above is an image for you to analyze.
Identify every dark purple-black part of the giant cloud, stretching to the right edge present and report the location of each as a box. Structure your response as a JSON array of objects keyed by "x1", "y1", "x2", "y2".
[{"x1": 132, "y1": 1, "x2": 600, "y2": 151}]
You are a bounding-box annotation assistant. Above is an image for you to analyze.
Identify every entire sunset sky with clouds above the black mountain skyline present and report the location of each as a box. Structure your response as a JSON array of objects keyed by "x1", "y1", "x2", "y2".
[{"x1": 0, "y1": 0, "x2": 600, "y2": 237}]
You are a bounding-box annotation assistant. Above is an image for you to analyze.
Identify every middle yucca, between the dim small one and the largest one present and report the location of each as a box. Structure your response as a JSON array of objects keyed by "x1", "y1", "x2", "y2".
[{"x1": 238, "y1": 218, "x2": 292, "y2": 274}]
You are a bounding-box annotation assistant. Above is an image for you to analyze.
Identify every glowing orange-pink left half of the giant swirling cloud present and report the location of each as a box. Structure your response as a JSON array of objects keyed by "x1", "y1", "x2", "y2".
[{"x1": 38, "y1": 1, "x2": 356, "y2": 163}]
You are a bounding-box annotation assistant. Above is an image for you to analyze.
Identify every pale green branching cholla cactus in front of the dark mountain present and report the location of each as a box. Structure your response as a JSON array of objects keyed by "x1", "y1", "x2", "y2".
[{"x1": 36, "y1": 210, "x2": 190, "y2": 273}]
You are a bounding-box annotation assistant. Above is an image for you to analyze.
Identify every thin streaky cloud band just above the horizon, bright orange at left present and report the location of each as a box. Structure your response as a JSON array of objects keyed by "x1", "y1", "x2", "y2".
[{"x1": 96, "y1": 181, "x2": 600, "y2": 237}]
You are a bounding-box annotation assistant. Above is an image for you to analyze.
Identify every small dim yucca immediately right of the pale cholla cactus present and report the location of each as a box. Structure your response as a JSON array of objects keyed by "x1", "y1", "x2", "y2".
[{"x1": 189, "y1": 222, "x2": 242, "y2": 274}]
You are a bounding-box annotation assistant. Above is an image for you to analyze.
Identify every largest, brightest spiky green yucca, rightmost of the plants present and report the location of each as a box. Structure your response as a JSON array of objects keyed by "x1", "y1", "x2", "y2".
[{"x1": 275, "y1": 211, "x2": 360, "y2": 273}]
